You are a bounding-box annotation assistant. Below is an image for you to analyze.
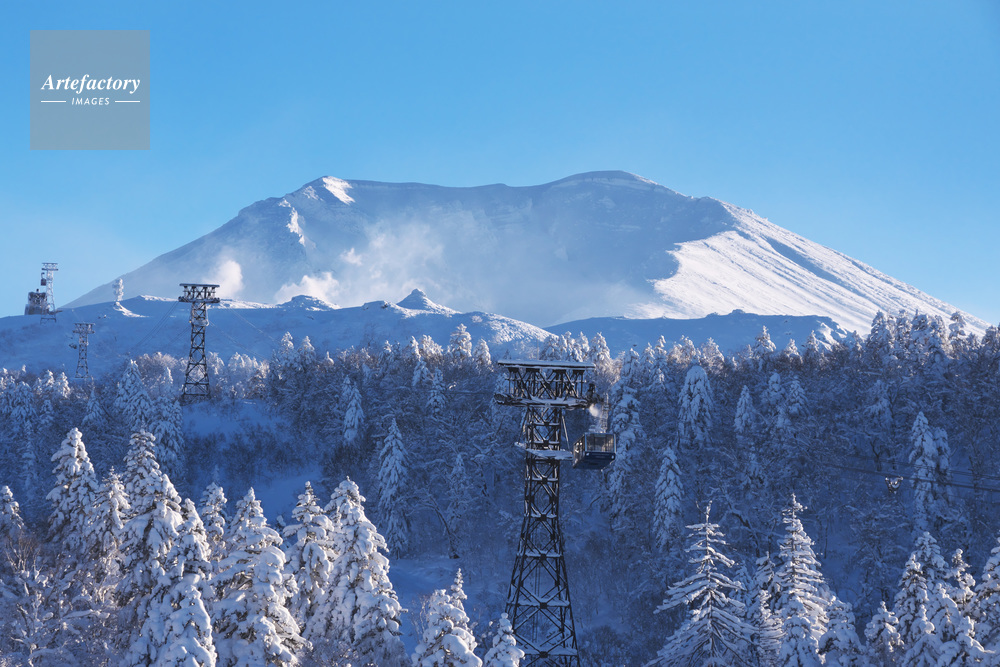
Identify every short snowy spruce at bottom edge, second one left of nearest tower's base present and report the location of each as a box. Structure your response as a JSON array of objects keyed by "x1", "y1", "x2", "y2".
[{"x1": 413, "y1": 590, "x2": 483, "y2": 667}]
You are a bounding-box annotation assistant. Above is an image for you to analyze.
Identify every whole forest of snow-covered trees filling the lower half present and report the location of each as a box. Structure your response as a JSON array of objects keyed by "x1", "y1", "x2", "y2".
[{"x1": 0, "y1": 313, "x2": 1000, "y2": 666}]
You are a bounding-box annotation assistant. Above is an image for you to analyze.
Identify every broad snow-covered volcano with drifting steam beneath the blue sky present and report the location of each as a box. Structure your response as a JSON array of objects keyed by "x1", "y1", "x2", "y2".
[{"x1": 64, "y1": 172, "x2": 986, "y2": 331}]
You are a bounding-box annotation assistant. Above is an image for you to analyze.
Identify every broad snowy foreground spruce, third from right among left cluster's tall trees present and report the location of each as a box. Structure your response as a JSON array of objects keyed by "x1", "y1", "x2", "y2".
[{"x1": 218, "y1": 489, "x2": 308, "y2": 667}]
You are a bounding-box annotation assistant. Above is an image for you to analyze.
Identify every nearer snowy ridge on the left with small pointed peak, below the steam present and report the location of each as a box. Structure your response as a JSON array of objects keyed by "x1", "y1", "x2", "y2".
[{"x1": 0, "y1": 290, "x2": 550, "y2": 377}]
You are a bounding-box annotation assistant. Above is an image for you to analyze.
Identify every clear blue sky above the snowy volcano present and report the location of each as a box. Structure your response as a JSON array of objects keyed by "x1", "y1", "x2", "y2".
[{"x1": 0, "y1": 0, "x2": 1000, "y2": 323}]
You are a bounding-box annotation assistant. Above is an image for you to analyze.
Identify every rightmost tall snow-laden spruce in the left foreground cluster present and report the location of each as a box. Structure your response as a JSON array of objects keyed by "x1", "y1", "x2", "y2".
[{"x1": 316, "y1": 479, "x2": 404, "y2": 665}]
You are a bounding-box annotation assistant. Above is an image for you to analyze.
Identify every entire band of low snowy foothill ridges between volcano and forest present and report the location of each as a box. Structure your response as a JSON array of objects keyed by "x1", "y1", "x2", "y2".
[{"x1": 0, "y1": 289, "x2": 846, "y2": 377}]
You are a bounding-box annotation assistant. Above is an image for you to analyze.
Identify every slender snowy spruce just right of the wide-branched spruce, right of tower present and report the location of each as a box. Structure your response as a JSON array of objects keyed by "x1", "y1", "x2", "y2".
[{"x1": 774, "y1": 494, "x2": 830, "y2": 642}]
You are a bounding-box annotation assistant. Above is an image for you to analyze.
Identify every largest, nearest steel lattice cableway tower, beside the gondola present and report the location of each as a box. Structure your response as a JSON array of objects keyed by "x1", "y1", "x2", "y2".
[{"x1": 496, "y1": 361, "x2": 594, "y2": 667}]
